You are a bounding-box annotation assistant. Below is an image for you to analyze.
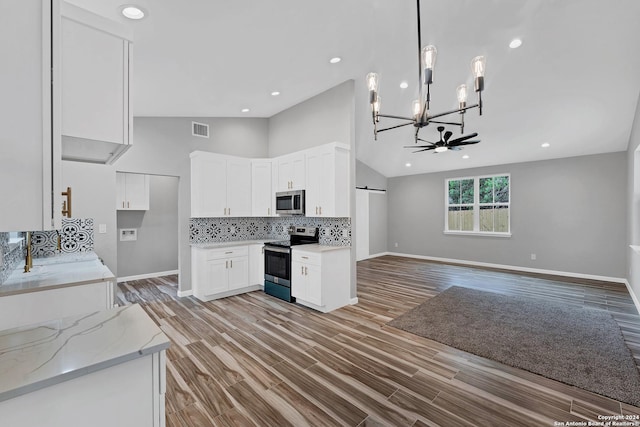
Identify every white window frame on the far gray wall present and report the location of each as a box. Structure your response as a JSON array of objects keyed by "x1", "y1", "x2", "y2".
[{"x1": 444, "y1": 173, "x2": 511, "y2": 237}]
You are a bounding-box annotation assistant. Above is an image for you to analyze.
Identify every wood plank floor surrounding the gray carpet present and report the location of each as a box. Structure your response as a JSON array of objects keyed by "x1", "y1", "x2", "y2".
[{"x1": 118, "y1": 256, "x2": 640, "y2": 427}]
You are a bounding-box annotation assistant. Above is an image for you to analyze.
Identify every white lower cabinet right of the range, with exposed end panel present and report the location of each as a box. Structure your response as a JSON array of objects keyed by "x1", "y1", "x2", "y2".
[{"x1": 291, "y1": 245, "x2": 351, "y2": 313}]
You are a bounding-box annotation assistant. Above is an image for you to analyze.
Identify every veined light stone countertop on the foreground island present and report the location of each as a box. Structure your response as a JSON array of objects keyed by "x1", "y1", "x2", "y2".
[{"x1": 0, "y1": 304, "x2": 169, "y2": 402}]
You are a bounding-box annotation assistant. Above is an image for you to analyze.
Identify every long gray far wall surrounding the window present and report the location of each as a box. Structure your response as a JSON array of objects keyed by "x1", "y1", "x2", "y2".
[{"x1": 387, "y1": 152, "x2": 627, "y2": 278}]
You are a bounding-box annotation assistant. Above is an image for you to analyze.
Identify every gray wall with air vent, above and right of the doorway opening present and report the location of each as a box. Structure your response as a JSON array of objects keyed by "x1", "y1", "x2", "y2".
[{"x1": 113, "y1": 117, "x2": 268, "y2": 291}]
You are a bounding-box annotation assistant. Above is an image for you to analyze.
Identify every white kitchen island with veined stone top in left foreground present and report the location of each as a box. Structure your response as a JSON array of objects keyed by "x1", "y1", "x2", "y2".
[{"x1": 0, "y1": 305, "x2": 169, "y2": 427}]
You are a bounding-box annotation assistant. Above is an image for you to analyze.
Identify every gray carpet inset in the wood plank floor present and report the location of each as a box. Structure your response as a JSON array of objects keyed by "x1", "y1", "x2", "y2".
[{"x1": 387, "y1": 286, "x2": 640, "y2": 406}]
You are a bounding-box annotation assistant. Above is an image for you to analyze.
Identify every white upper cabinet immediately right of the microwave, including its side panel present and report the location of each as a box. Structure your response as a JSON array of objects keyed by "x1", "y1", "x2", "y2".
[{"x1": 305, "y1": 143, "x2": 350, "y2": 217}]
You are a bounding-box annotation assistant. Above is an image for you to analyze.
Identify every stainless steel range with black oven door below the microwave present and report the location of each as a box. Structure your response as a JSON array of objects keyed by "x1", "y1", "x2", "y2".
[{"x1": 264, "y1": 226, "x2": 319, "y2": 302}]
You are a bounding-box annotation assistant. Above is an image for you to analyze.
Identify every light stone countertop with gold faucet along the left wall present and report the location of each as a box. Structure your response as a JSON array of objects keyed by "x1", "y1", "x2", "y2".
[{"x1": 0, "y1": 252, "x2": 115, "y2": 297}]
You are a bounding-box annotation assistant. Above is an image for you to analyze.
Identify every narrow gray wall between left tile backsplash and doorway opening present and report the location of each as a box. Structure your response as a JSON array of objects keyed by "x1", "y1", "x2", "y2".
[{"x1": 62, "y1": 161, "x2": 118, "y2": 275}]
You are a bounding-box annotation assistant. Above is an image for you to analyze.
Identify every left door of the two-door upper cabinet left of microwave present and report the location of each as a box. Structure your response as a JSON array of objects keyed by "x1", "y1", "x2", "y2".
[{"x1": 191, "y1": 152, "x2": 227, "y2": 218}]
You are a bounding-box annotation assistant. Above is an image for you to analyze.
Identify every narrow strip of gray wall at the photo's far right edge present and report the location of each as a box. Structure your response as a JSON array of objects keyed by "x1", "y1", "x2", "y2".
[{"x1": 626, "y1": 92, "x2": 640, "y2": 298}]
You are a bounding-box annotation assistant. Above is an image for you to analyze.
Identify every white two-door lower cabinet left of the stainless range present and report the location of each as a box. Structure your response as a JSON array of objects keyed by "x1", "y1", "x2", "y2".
[{"x1": 191, "y1": 245, "x2": 260, "y2": 301}]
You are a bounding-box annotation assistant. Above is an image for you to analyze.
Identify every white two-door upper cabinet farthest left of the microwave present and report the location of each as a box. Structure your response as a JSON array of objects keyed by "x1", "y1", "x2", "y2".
[{"x1": 191, "y1": 151, "x2": 251, "y2": 217}]
